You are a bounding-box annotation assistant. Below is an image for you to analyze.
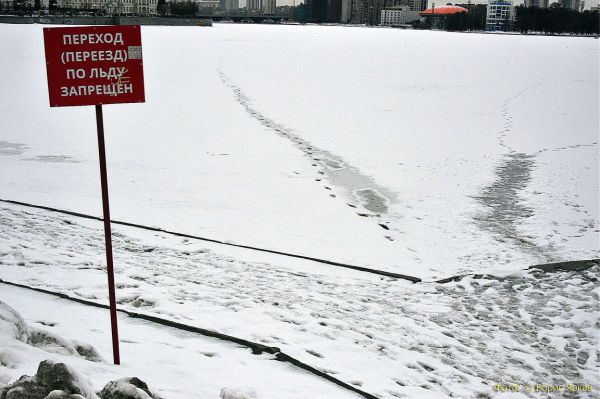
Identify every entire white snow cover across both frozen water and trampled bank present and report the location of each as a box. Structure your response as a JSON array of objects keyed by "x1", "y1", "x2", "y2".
[{"x1": 0, "y1": 24, "x2": 600, "y2": 399}]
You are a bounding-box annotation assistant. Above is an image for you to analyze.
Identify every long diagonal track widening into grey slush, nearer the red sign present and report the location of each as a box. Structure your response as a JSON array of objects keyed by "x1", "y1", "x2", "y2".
[{"x1": 218, "y1": 70, "x2": 396, "y2": 241}]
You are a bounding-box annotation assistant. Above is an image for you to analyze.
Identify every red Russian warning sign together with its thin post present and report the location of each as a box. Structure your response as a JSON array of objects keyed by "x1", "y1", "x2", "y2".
[{"x1": 44, "y1": 25, "x2": 145, "y2": 364}]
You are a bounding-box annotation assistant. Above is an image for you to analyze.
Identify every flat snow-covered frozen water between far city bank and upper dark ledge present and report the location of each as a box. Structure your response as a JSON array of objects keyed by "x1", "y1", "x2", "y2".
[{"x1": 0, "y1": 24, "x2": 599, "y2": 278}]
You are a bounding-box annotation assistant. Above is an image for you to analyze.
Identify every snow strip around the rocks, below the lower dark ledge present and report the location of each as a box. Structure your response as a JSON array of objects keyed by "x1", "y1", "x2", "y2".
[{"x1": 0, "y1": 285, "x2": 359, "y2": 399}]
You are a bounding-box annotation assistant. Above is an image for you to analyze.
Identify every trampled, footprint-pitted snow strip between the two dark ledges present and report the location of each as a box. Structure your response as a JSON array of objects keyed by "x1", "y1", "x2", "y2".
[{"x1": 0, "y1": 207, "x2": 600, "y2": 398}]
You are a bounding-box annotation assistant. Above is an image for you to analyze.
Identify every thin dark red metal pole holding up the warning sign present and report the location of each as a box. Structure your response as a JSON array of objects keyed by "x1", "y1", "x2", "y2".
[{"x1": 96, "y1": 105, "x2": 121, "y2": 364}]
